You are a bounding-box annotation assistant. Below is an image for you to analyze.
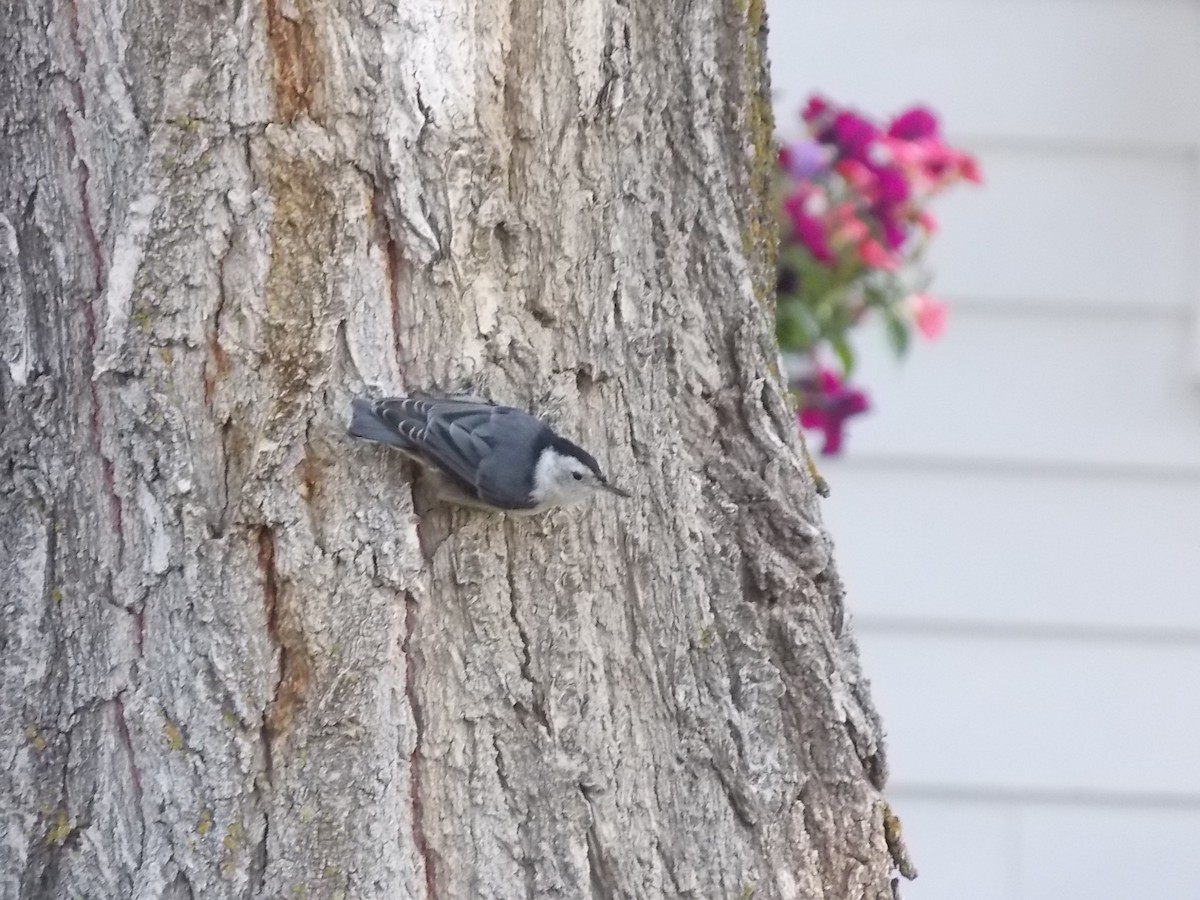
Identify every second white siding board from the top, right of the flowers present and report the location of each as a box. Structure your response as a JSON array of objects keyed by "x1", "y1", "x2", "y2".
[{"x1": 930, "y1": 149, "x2": 1198, "y2": 310}]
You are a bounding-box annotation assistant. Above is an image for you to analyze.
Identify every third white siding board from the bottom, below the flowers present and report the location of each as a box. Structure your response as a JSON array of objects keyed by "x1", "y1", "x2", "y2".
[{"x1": 822, "y1": 468, "x2": 1200, "y2": 628}]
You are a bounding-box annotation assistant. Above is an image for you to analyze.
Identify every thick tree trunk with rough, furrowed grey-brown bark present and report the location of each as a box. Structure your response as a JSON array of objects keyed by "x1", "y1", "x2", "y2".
[{"x1": 0, "y1": 0, "x2": 895, "y2": 900}]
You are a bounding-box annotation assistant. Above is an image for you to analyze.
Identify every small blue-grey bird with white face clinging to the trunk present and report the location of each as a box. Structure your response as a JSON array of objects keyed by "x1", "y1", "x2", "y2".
[{"x1": 347, "y1": 397, "x2": 629, "y2": 515}]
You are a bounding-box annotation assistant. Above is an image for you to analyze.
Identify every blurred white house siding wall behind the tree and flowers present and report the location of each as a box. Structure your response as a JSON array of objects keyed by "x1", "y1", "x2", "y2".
[{"x1": 768, "y1": 0, "x2": 1200, "y2": 900}]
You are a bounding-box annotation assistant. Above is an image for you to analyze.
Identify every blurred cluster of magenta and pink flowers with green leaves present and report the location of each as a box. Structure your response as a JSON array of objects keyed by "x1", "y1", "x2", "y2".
[{"x1": 776, "y1": 97, "x2": 980, "y2": 454}]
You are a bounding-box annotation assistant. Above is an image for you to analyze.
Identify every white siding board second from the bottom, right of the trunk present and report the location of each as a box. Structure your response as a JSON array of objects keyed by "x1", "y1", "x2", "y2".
[{"x1": 859, "y1": 634, "x2": 1200, "y2": 797}]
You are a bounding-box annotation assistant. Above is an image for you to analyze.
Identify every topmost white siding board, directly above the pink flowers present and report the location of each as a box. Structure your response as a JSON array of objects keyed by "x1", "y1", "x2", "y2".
[{"x1": 768, "y1": 0, "x2": 1200, "y2": 146}]
